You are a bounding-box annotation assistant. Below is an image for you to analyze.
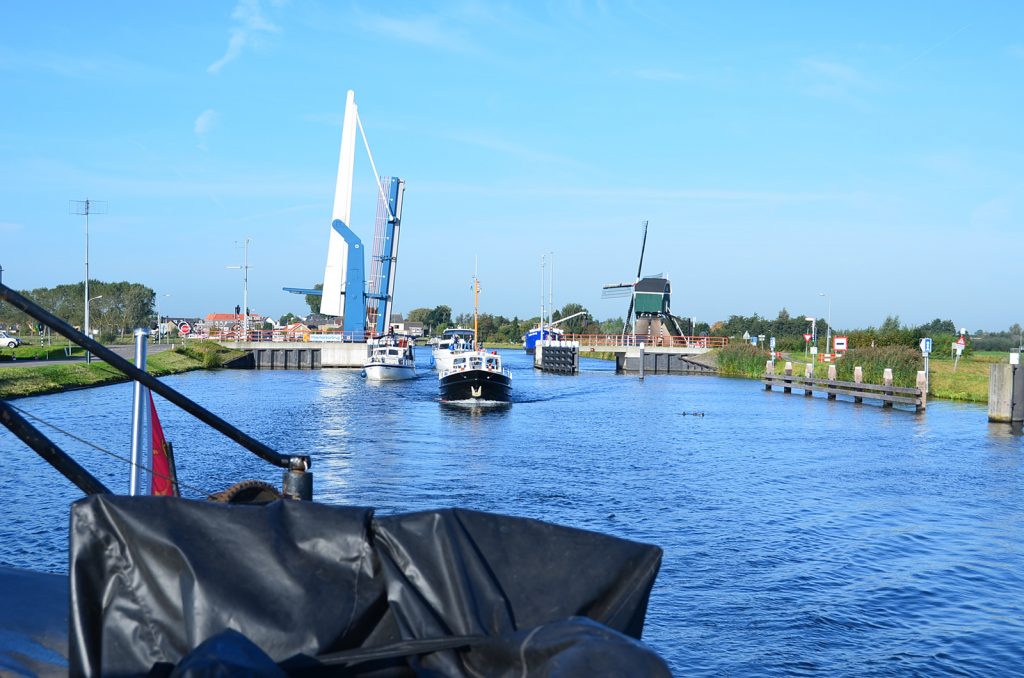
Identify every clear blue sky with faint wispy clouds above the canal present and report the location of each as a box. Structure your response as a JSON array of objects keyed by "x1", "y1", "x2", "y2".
[{"x1": 0, "y1": 0, "x2": 1024, "y2": 330}]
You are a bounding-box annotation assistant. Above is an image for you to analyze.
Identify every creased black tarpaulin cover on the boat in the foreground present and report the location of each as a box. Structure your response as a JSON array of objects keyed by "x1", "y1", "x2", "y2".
[{"x1": 69, "y1": 495, "x2": 669, "y2": 676}]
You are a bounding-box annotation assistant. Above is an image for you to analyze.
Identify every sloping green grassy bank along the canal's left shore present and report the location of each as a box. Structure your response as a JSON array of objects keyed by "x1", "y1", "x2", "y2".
[{"x1": 0, "y1": 342, "x2": 242, "y2": 399}]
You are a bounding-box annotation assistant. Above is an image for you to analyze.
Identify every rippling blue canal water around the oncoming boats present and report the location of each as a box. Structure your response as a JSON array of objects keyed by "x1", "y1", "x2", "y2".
[{"x1": 0, "y1": 349, "x2": 1024, "y2": 675}]
